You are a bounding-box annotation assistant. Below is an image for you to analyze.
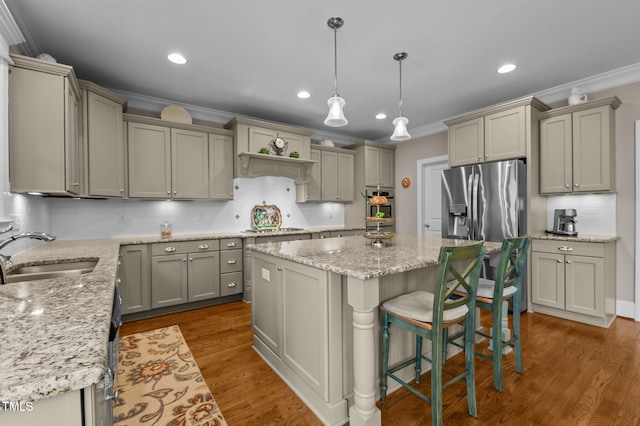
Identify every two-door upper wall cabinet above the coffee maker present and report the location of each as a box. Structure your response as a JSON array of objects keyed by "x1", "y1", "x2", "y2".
[{"x1": 540, "y1": 97, "x2": 620, "y2": 194}]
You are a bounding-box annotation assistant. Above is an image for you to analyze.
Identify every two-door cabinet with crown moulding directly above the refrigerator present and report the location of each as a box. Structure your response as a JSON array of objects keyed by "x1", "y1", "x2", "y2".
[{"x1": 444, "y1": 97, "x2": 549, "y2": 167}]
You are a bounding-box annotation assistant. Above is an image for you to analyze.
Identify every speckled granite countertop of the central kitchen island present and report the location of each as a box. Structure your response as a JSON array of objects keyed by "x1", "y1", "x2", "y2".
[{"x1": 247, "y1": 235, "x2": 502, "y2": 280}]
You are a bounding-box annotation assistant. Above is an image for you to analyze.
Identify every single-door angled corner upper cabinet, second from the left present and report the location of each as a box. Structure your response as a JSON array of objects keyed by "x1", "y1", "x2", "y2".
[{"x1": 78, "y1": 80, "x2": 127, "y2": 198}]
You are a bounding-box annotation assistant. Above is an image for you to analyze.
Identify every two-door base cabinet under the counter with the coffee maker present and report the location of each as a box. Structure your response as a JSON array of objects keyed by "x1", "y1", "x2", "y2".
[{"x1": 531, "y1": 239, "x2": 616, "y2": 327}]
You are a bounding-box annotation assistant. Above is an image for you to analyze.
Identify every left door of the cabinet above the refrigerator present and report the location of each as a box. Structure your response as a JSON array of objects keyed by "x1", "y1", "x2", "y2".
[{"x1": 449, "y1": 117, "x2": 484, "y2": 167}]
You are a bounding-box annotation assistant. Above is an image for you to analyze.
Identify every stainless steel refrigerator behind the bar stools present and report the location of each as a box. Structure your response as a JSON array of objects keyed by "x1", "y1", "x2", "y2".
[{"x1": 442, "y1": 160, "x2": 527, "y2": 310}]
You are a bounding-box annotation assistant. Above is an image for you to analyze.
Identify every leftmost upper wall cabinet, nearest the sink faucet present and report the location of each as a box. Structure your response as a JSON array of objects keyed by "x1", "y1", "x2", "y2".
[{"x1": 9, "y1": 54, "x2": 83, "y2": 196}]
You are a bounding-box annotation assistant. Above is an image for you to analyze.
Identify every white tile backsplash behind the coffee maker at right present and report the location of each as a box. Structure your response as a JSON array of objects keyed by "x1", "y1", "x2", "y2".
[{"x1": 547, "y1": 194, "x2": 616, "y2": 235}]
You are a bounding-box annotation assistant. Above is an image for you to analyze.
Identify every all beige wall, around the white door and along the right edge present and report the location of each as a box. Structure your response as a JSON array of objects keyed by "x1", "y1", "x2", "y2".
[{"x1": 396, "y1": 83, "x2": 640, "y2": 304}]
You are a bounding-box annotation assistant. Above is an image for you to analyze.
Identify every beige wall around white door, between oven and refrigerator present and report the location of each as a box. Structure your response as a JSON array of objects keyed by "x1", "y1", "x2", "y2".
[{"x1": 395, "y1": 132, "x2": 447, "y2": 235}]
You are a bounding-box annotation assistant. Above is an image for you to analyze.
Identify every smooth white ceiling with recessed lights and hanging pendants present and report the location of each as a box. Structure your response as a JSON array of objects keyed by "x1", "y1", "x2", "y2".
[{"x1": 4, "y1": 0, "x2": 640, "y2": 140}]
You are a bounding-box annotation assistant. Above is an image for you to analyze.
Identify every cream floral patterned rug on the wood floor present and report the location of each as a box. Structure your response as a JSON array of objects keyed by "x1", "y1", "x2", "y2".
[{"x1": 113, "y1": 325, "x2": 227, "y2": 426}]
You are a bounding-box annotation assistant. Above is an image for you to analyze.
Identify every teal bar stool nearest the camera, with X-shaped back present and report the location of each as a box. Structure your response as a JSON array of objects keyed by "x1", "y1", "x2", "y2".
[{"x1": 380, "y1": 243, "x2": 485, "y2": 425}]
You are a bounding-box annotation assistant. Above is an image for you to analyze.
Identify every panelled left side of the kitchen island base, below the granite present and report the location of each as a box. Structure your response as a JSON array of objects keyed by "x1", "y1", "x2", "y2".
[{"x1": 251, "y1": 253, "x2": 348, "y2": 425}]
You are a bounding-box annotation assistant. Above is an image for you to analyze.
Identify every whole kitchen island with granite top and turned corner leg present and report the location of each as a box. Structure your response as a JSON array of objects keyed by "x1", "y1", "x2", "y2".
[{"x1": 248, "y1": 236, "x2": 501, "y2": 425}]
